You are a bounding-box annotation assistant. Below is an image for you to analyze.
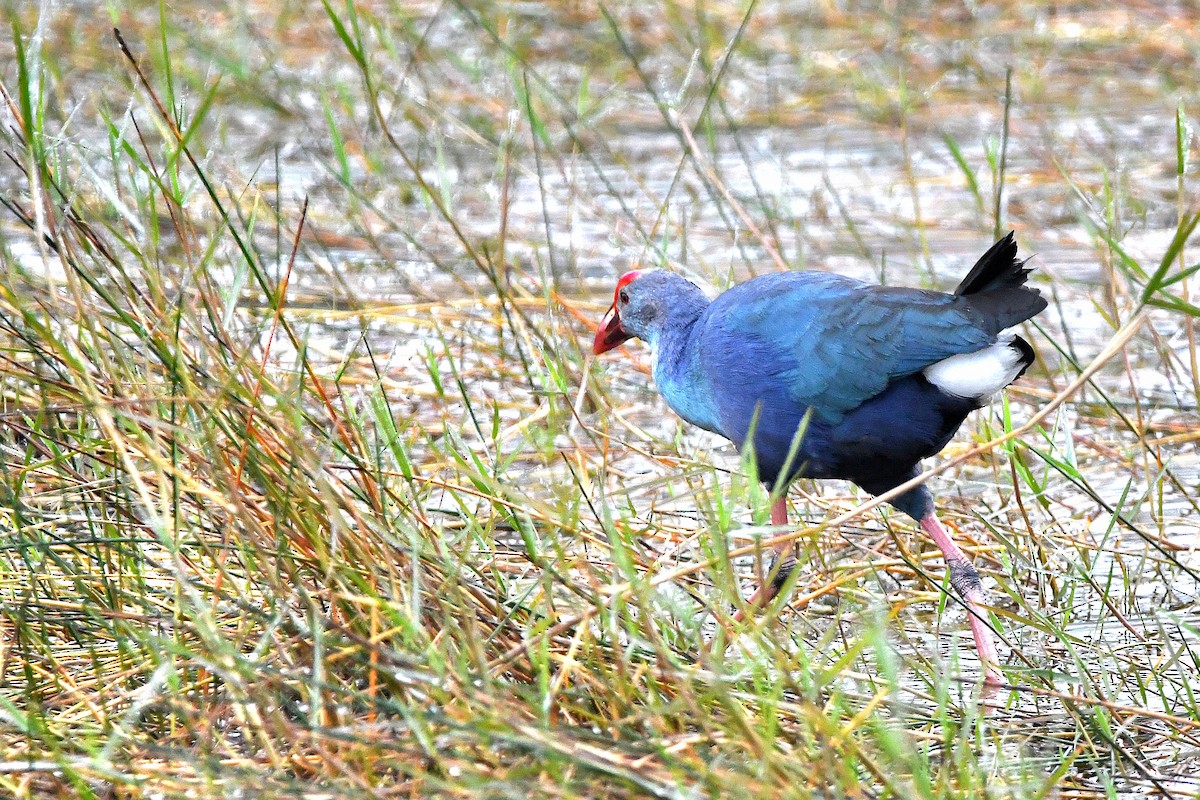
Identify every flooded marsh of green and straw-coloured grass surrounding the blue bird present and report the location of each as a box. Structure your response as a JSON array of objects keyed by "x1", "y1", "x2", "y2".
[{"x1": 0, "y1": 0, "x2": 1200, "y2": 798}]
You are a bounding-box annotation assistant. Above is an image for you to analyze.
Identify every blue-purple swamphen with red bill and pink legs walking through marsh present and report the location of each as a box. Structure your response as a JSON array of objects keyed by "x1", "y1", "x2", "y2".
[{"x1": 593, "y1": 233, "x2": 1046, "y2": 685}]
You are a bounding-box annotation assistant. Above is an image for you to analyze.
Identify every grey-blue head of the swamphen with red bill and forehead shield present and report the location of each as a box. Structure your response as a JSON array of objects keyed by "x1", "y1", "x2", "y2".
[{"x1": 592, "y1": 270, "x2": 708, "y2": 355}]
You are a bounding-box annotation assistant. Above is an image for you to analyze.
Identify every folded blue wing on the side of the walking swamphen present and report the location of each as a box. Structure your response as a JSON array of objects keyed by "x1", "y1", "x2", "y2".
[{"x1": 697, "y1": 272, "x2": 996, "y2": 434}]
